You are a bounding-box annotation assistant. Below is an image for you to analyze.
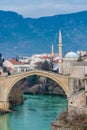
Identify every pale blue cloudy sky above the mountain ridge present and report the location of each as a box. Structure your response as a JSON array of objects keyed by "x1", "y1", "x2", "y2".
[{"x1": 0, "y1": 0, "x2": 87, "y2": 18}]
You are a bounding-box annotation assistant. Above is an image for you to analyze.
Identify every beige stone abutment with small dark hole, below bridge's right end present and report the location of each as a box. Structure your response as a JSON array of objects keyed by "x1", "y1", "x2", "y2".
[{"x1": 68, "y1": 91, "x2": 86, "y2": 116}]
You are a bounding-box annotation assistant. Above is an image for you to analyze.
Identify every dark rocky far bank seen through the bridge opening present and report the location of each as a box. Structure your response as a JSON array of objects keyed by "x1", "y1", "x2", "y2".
[{"x1": 24, "y1": 77, "x2": 66, "y2": 97}]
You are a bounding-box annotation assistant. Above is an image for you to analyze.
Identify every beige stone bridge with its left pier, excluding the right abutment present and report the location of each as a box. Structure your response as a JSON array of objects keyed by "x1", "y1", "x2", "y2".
[{"x1": 0, "y1": 70, "x2": 71, "y2": 110}]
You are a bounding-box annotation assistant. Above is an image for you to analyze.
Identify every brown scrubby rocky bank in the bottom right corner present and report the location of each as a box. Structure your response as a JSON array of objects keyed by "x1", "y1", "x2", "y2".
[{"x1": 51, "y1": 112, "x2": 87, "y2": 130}]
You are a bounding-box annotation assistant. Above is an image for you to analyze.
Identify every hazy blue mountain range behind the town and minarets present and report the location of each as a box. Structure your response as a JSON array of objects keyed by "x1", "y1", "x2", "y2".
[{"x1": 0, "y1": 11, "x2": 87, "y2": 57}]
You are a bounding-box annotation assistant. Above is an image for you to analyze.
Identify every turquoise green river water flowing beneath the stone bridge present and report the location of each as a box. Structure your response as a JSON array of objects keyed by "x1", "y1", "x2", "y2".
[{"x1": 0, "y1": 95, "x2": 67, "y2": 130}]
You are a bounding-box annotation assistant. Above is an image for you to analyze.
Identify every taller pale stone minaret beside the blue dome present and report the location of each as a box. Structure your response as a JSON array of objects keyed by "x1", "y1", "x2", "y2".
[{"x1": 58, "y1": 30, "x2": 63, "y2": 73}]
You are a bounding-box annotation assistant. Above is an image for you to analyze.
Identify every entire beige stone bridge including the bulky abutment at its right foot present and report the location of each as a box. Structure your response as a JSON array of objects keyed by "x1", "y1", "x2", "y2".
[{"x1": 0, "y1": 70, "x2": 87, "y2": 115}]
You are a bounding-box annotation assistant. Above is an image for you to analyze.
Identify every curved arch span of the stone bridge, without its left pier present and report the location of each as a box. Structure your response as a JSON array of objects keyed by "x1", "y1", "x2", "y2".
[{"x1": 6, "y1": 70, "x2": 70, "y2": 101}]
